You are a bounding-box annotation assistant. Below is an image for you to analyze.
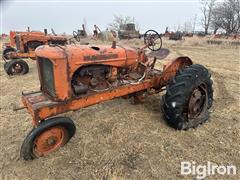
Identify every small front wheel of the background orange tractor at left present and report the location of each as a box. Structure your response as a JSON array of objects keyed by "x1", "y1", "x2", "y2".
[{"x1": 4, "y1": 60, "x2": 29, "y2": 75}]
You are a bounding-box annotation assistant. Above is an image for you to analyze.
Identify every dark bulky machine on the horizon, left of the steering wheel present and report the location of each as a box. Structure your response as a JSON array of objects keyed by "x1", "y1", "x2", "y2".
[{"x1": 118, "y1": 23, "x2": 141, "y2": 39}]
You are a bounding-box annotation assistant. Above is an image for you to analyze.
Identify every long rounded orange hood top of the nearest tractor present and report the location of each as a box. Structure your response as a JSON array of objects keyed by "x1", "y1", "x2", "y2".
[{"x1": 35, "y1": 44, "x2": 137, "y2": 61}]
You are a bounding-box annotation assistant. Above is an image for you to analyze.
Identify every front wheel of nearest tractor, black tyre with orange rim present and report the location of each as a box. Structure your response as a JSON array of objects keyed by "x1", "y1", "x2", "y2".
[{"x1": 20, "y1": 117, "x2": 76, "y2": 160}]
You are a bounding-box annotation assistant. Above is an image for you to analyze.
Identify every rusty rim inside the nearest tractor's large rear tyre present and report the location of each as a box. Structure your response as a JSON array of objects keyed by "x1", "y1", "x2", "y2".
[{"x1": 188, "y1": 83, "x2": 208, "y2": 120}]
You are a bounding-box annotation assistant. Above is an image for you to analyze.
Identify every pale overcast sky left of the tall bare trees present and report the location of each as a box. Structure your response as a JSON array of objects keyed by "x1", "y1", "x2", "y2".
[{"x1": 0, "y1": 0, "x2": 201, "y2": 33}]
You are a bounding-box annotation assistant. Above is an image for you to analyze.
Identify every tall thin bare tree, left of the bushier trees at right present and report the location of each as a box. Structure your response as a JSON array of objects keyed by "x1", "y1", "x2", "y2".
[{"x1": 201, "y1": 0, "x2": 216, "y2": 34}]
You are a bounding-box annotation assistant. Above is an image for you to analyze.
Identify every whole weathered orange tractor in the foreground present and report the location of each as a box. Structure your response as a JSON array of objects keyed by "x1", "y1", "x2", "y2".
[{"x1": 16, "y1": 30, "x2": 213, "y2": 160}]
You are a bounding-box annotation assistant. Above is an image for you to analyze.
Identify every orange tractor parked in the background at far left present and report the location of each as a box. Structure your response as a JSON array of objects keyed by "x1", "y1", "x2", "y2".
[{"x1": 2, "y1": 28, "x2": 67, "y2": 75}]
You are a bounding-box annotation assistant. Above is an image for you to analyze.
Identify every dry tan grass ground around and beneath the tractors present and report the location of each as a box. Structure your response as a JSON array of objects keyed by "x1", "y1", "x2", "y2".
[{"x1": 0, "y1": 38, "x2": 240, "y2": 180}]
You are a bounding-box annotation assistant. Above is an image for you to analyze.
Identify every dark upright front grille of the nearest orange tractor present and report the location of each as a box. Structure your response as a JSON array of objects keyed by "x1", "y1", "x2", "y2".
[{"x1": 37, "y1": 57, "x2": 56, "y2": 97}]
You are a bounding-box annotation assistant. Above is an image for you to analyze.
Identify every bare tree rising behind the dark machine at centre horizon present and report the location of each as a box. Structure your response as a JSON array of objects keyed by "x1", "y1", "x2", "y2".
[{"x1": 108, "y1": 15, "x2": 139, "y2": 31}]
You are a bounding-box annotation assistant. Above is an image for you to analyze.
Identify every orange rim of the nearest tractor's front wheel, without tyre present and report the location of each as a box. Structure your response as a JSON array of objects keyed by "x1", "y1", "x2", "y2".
[{"x1": 33, "y1": 126, "x2": 67, "y2": 156}]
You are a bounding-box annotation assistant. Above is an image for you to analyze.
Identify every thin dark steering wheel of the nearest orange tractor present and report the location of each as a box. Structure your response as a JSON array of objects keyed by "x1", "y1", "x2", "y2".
[{"x1": 144, "y1": 30, "x2": 162, "y2": 51}]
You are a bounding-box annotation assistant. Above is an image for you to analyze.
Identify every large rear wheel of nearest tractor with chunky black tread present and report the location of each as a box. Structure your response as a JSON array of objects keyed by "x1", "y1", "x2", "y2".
[{"x1": 163, "y1": 64, "x2": 213, "y2": 130}]
